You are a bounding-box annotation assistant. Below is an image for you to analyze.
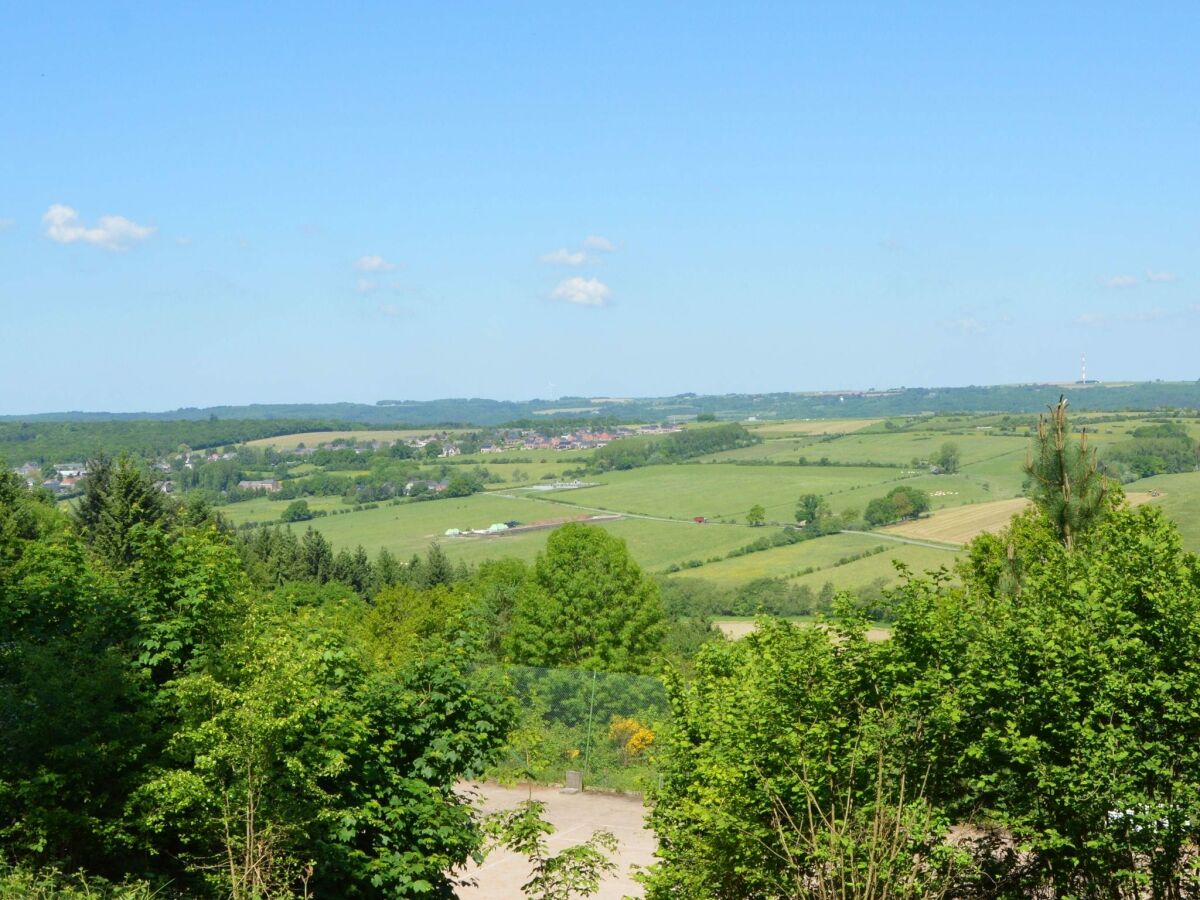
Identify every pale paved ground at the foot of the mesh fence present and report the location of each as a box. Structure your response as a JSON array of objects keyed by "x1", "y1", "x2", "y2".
[{"x1": 458, "y1": 784, "x2": 654, "y2": 900}]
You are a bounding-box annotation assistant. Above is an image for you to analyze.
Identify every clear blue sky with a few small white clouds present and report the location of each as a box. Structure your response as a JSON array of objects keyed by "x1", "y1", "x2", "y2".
[{"x1": 0, "y1": 2, "x2": 1200, "y2": 413}]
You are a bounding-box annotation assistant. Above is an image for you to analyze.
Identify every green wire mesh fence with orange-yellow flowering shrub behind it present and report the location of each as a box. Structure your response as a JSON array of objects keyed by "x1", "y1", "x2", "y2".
[{"x1": 491, "y1": 666, "x2": 668, "y2": 791}]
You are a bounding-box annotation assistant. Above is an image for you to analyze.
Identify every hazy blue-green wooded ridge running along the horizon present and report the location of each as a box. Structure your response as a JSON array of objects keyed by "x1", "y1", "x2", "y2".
[{"x1": 7, "y1": 382, "x2": 1200, "y2": 427}]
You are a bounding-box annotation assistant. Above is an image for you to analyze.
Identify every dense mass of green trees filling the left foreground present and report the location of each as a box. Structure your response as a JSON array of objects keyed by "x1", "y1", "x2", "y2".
[{"x1": 0, "y1": 464, "x2": 514, "y2": 898}]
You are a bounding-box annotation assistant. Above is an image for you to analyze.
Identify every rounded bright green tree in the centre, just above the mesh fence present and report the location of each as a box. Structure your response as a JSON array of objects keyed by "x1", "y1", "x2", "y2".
[{"x1": 505, "y1": 523, "x2": 664, "y2": 672}]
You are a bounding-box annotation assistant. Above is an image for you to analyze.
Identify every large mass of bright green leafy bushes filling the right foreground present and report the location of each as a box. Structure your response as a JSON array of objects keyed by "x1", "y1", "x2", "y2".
[{"x1": 649, "y1": 502, "x2": 1200, "y2": 898}]
